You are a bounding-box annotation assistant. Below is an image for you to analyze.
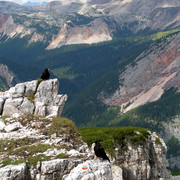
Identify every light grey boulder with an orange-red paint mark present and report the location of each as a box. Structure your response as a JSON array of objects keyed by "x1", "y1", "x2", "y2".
[{"x1": 63, "y1": 159, "x2": 113, "y2": 180}]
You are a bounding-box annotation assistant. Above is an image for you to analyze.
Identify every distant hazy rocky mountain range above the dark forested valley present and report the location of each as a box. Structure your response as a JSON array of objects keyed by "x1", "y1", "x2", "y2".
[{"x1": 0, "y1": 0, "x2": 180, "y2": 50}]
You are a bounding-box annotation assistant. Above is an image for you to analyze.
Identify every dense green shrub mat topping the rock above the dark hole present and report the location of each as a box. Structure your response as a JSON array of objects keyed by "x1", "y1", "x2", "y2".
[{"x1": 78, "y1": 127, "x2": 149, "y2": 156}]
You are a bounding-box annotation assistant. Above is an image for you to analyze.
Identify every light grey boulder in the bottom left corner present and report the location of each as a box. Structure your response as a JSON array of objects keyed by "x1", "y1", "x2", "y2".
[{"x1": 0, "y1": 163, "x2": 26, "y2": 180}]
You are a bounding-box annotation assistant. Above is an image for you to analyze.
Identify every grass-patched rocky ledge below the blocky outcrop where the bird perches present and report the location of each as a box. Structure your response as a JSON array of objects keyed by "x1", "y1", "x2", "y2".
[{"x1": 0, "y1": 115, "x2": 92, "y2": 180}]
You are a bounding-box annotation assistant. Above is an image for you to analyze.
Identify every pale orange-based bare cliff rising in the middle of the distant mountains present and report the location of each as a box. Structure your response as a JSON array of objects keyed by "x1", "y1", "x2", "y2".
[{"x1": 46, "y1": 19, "x2": 112, "y2": 50}]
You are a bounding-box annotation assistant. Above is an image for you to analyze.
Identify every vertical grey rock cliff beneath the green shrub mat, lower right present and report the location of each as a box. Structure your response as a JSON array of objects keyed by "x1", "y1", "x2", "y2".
[{"x1": 115, "y1": 133, "x2": 172, "y2": 180}]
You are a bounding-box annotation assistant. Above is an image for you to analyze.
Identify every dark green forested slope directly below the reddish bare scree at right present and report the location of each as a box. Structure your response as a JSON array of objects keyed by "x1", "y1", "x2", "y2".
[{"x1": 110, "y1": 89, "x2": 180, "y2": 132}]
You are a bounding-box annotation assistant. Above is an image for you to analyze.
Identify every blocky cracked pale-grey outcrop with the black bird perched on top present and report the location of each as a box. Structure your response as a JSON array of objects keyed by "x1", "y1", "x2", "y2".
[{"x1": 0, "y1": 79, "x2": 67, "y2": 117}]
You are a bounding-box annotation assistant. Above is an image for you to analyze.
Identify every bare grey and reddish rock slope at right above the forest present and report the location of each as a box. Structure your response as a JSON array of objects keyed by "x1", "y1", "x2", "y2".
[{"x1": 99, "y1": 33, "x2": 180, "y2": 112}]
